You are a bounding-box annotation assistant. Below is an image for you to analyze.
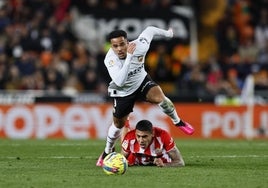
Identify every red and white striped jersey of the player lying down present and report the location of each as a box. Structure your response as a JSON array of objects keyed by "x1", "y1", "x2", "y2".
[{"x1": 122, "y1": 127, "x2": 175, "y2": 165}]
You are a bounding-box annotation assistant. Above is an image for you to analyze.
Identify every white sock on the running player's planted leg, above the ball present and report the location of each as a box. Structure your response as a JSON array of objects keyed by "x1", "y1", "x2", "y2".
[{"x1": 104, "y1": 123, "x2": 121, "y2": 153}]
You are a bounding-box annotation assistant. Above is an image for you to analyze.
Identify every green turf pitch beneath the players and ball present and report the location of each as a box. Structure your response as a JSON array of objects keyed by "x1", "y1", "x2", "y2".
[{"x1": 0, "y1": 139, "x2": 268, "y2": 188}]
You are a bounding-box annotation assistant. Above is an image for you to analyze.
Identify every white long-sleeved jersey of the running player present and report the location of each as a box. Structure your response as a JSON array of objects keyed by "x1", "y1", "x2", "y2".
[{"x1": 104, "y1": 26, "x2": 173, "y2": 97}]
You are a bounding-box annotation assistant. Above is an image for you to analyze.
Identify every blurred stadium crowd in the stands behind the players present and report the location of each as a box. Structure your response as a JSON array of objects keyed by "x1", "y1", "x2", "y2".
[{"x1": 0, "y1": 0, "x2": 268, "y2": 101}]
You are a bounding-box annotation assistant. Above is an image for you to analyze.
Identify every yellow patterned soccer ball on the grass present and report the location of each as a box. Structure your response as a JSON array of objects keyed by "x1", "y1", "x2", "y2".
[{"x1": 102, "y1": 152, "x2": 128, "y2": 175}]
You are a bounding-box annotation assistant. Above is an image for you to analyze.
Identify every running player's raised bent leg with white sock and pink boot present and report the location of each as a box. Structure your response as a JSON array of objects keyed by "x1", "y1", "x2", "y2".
[{"x1": 146, "y1": 85, "x2": 194, "y2": 135}]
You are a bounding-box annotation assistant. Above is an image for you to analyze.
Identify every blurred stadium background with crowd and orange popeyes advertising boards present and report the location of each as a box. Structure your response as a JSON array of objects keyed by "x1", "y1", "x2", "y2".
[{"x1": 0, "y1": 0, "x2": 268, "y2": 139}]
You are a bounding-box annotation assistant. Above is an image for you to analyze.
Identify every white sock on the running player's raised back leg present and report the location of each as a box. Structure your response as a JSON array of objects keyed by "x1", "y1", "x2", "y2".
[{"x1": 158, "y1": 97, "x2": 181, "y2": 124}]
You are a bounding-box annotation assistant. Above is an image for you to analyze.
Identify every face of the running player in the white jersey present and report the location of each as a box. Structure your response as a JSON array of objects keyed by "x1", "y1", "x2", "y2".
[{"x1": 111, "y1": 37, "x2": 128, "y2": 59}]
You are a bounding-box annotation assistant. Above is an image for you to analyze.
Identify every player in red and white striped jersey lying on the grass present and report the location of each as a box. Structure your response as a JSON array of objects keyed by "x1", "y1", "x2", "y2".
[{"x1": 121, "y1": 120, "x2": 185, "y2": 167}]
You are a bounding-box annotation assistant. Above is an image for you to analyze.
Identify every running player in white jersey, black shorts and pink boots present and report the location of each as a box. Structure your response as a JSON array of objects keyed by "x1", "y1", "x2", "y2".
[{"x1": 96, "y1": 26, "x2": 194, "y2": 166}]
